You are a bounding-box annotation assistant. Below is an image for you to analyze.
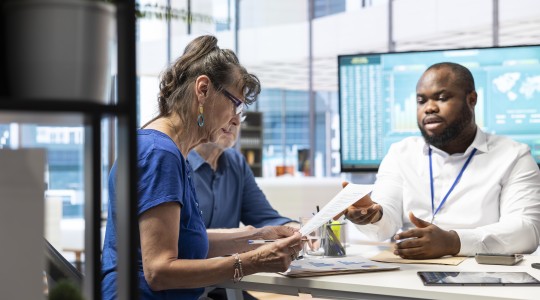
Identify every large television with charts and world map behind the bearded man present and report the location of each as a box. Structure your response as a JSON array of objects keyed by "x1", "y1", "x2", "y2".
[{"x1": 338, "y1": 45, "x2": 540, "y2": 172}]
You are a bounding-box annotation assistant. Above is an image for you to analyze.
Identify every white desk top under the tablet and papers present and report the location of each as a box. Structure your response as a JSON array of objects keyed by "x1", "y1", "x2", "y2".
[{"x1": 218, "y1": 249, "x2": 540, "y2": 300}]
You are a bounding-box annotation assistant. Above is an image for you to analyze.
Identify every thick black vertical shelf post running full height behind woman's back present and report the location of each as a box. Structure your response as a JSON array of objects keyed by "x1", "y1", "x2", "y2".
[{"x1": 116, "y1": 0, "x2": 139, "y2": 300}]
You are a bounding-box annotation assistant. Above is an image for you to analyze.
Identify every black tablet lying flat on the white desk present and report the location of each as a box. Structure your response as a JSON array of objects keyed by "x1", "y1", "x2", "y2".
[{"x1": 418, "y1": 272, "x2": 540, "y2": 286}]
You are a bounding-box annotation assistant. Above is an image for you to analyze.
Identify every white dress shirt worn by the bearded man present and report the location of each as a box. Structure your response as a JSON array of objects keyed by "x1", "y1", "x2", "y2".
[{"x1": 357, "y1": 128, "x2": 540, "y2": 256}]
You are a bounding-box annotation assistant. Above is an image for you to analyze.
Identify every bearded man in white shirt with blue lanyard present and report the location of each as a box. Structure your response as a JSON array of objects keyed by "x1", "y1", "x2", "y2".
[{"x1": 345, "y1": 63, "x2": 540, "y2": 259}]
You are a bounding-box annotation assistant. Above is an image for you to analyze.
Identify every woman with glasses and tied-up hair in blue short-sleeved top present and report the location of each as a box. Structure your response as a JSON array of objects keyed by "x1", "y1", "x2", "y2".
[{"x1": 102, "y1": 36, "x2": 302, "y2": 299}]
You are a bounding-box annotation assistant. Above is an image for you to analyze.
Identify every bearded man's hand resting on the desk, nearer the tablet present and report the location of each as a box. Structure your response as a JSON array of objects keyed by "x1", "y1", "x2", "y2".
[{"x1": 394, "y1": 212, "x2": 461, "y2": 259}]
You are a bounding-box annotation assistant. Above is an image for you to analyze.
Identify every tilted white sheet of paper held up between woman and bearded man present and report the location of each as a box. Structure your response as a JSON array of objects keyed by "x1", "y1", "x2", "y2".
[{"x1": 300, "y1": 183, "x2": 372, "y2": 236}]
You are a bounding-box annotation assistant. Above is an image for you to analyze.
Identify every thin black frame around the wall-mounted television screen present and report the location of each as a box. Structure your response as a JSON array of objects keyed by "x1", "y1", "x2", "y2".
[{"x1": 337, "y1": 44, "x2": 540, "y2": 173}]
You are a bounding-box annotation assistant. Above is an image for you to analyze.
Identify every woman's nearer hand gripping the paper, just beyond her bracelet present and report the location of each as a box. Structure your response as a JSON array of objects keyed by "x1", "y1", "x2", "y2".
[{"x1": 245, "y1": 232, "x2": 302, "y2": 274}]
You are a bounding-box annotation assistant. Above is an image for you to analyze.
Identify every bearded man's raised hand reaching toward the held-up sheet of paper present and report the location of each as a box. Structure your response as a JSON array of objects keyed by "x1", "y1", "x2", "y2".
[{"x1": 334, "y1": 181, "x2": 382, "y2": 225}]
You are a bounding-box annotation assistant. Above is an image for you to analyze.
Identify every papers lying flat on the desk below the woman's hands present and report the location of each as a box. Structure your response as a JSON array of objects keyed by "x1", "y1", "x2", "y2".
[{"x1": 279, "y1": 256, "x2": 399, "y2": 277}]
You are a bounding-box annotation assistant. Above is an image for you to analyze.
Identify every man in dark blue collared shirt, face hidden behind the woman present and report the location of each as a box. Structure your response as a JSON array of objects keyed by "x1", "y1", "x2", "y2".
[{"x1": 188, "y1": 112, "x2": 297, "y2": 228}]
